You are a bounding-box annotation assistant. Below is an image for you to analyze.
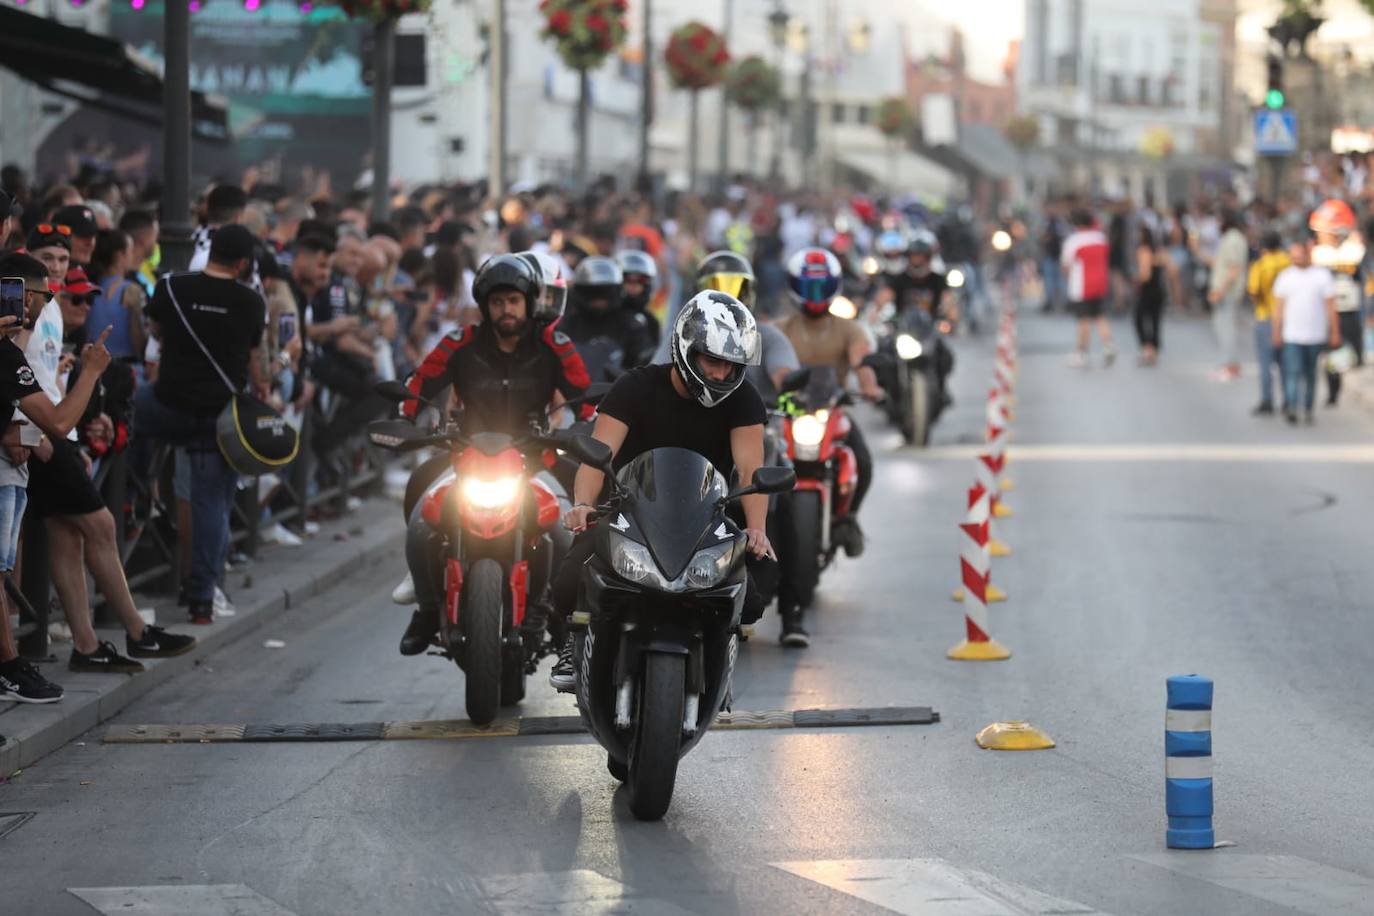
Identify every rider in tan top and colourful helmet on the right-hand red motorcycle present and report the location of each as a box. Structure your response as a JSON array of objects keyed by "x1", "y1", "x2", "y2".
[{"x1": 779, "y1": 249, "x2": 883, "y2": 556}]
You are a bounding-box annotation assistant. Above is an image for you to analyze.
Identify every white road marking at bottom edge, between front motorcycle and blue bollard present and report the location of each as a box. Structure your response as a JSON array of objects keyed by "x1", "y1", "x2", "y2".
[{"x1": 772, "y1": 858, "x2": 1102, "y2": 916}]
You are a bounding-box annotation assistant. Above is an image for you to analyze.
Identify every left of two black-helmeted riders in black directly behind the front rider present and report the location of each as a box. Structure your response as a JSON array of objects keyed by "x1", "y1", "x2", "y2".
[{"x1": 559, "y1": 255, "x2": 653, "y2": 382}]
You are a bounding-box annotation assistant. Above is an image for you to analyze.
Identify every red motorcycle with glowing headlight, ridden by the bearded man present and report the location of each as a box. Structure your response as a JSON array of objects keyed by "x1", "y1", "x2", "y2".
[{"x1": 368, "y1": 383, "x2": 609, "y2": 725}]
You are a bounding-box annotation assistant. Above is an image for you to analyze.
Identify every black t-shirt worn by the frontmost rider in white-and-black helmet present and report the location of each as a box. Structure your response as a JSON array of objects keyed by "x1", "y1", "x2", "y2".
[{"x1": 598, "y1": 365, "x2": 768, "y2": 479}]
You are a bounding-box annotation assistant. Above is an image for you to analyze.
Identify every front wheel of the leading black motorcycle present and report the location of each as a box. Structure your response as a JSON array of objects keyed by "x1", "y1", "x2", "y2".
[{"x1": 625, "y1": 652, "x2": 687, "y2": 821}]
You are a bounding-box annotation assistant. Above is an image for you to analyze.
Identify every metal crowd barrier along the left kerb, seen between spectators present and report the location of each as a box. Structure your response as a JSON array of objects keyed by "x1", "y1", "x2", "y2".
[{"x1": 14, "y1": 407, "x2": 390, "y2": 658}]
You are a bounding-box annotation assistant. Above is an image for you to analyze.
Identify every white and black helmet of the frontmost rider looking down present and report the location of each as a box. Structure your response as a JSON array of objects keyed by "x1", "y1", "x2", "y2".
[{"x1": 671, "y1": 290, "x2": 763, "y2": 407}]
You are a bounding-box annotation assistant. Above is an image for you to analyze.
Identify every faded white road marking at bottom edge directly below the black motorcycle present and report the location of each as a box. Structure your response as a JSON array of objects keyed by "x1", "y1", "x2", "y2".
[{"x1": 475, "y1": 868, "x2": 691, "y2": 916}]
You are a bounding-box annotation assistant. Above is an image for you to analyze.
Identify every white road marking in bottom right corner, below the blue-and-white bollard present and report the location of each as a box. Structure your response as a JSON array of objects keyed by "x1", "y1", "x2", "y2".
[{"x1": 1132, "y1": 851, "x2": 1374, "y2": 916}]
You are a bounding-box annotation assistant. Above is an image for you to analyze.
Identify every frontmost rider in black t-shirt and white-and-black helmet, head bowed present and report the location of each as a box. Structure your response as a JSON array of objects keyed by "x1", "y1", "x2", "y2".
[{"x1": 550, "y1": 290, "x2": 778, "y2": 692}]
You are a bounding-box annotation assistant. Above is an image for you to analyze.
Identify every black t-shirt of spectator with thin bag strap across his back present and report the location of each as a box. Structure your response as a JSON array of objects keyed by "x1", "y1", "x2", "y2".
[{"x1": 148, "y1": 273, "x2": 267, "y2": 416}]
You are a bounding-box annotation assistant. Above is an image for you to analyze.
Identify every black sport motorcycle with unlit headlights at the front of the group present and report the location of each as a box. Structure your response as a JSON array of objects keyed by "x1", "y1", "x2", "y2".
[{"x1": 557, "y1": 437, "x2": 796, "y2": 820}]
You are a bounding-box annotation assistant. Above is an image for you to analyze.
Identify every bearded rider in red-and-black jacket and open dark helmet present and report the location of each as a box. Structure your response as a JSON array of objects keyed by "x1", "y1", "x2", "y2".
[{"x1": 393, "y1": 254, "x2": 591, "y2": 655}]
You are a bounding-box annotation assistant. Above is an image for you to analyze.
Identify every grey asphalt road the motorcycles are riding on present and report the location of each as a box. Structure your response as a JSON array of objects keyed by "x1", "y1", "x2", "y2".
[{"x1": 0, "y1": 316, "x2": 1374, "y2": 916}]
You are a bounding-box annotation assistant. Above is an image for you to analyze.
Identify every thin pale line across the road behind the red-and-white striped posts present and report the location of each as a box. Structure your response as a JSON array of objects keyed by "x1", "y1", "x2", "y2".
[{"x1": 912, "y1": 442, "x2": 1374, "y2": 464}]
